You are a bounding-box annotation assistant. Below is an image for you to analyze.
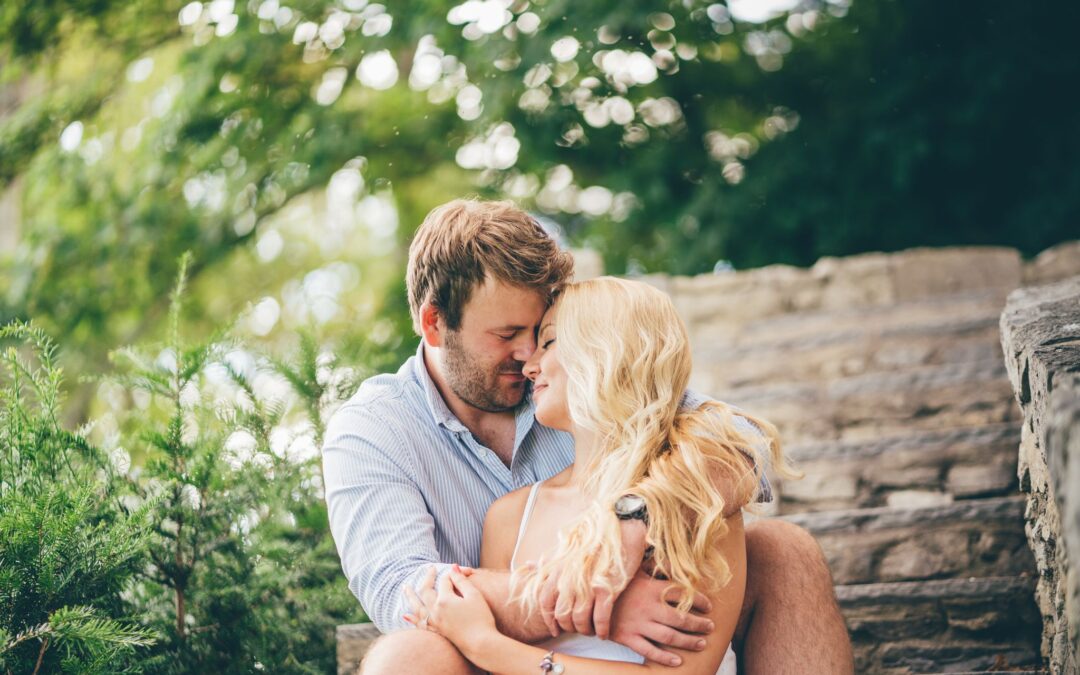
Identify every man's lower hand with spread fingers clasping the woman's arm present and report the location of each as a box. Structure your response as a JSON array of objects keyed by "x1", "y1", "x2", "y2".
[{"x1": 610, "y1": 572, "x2": 715, "y2": 666}]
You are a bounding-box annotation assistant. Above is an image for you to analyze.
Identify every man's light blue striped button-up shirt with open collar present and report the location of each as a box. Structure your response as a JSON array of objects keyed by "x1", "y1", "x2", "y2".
[{"x1": 323, "y1": 342, "x2": 769, "y2": 633}]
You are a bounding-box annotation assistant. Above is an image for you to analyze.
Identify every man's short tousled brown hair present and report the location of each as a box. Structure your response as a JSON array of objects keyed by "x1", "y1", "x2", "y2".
[{"x1": 405, "y1": 199, "x2": 573, "y2": 334}]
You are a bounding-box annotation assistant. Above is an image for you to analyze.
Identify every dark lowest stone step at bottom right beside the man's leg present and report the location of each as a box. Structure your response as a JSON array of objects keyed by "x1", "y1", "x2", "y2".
[{"x1": 836, "y1": 577, "x2": 1042, "y2": 675}]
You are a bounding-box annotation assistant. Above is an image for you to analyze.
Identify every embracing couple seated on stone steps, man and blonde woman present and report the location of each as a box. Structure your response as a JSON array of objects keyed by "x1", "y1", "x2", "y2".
[{"x1": 323, "y1": 200, "x2": 852, "y2": 675}]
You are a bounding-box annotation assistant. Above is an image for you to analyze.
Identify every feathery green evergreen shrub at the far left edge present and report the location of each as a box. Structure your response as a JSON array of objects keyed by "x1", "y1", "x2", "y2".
[{"x1": 0, "y1": 324, "x2": 154, "y2": 673}]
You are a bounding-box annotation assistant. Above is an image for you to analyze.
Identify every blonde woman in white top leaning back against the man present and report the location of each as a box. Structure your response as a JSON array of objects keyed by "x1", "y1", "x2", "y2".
[{"x1": 406, "y1": 278, "x2": 782, "y2": 675}]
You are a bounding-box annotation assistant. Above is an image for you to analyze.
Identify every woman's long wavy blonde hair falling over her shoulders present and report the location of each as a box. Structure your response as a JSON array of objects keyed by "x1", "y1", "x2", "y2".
[{"x1": 513, "y1": 276, "x2": 791, "y2": 611}]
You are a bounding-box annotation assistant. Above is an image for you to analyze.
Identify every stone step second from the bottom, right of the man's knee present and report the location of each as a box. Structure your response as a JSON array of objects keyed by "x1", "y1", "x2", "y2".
[{"x1": 783, "y1": 496, "x2": 1035, "y2": 584}]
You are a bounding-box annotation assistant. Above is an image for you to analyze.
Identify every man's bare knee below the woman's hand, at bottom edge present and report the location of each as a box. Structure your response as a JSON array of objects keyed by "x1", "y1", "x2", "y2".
[{"x1": 360, "y1": 629, "x2": 483, "y2": 675}]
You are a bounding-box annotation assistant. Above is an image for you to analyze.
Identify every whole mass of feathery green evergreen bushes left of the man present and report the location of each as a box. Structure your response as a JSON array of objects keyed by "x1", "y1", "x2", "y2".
[{"x1": 0, "y1": 259, "x2": 363, "y2": 673}]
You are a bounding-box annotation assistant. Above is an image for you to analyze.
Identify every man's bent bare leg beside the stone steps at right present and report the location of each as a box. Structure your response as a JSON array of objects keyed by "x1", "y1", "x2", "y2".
[{"x1": 733, "y1": 519, "x2": 854, "y2": 675}]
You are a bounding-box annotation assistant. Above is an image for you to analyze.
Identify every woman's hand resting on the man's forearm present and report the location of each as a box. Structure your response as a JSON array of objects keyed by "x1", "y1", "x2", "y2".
[{"x1": 405, "y1": 565, "x2": 498, "y2": 657}]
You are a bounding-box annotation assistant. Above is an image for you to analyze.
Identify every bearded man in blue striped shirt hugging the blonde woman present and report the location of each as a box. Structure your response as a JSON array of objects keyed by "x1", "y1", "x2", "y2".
[{"x1": 323, "y1": 200, "x2": 852, "y2": 675}]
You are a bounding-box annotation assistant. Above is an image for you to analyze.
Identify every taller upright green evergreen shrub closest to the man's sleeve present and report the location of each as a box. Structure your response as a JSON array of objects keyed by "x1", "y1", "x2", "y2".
[{"x1": 106, "y1": 258, "x2": 363, "y2": 673}]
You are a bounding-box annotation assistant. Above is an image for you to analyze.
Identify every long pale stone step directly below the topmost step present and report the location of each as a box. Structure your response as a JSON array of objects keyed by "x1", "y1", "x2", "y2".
[{"x1": 694, "y1": 314, "x2": 1001, "y2": 390}]
